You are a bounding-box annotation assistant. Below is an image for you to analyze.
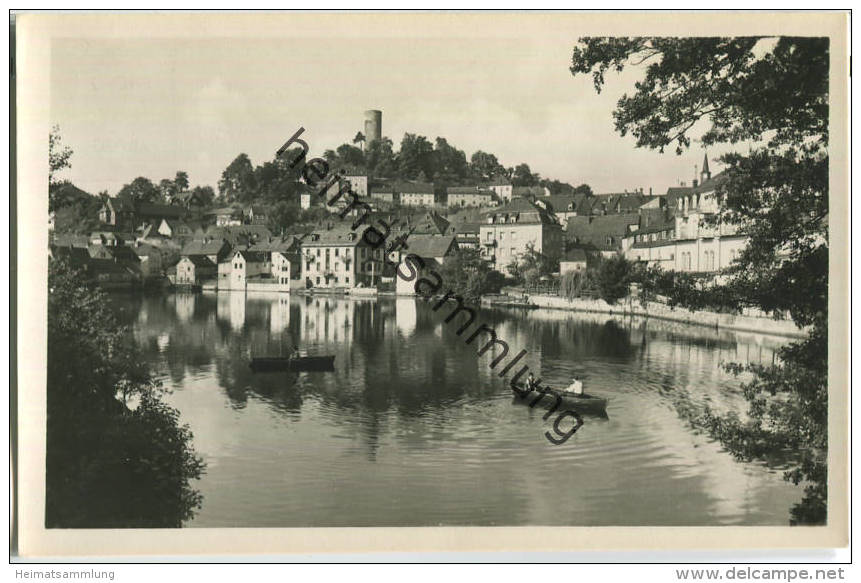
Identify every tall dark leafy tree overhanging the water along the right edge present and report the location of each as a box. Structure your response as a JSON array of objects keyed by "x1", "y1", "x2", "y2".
[{"x1": 570, "y1": 37, "x2": 829, "y2": 523}]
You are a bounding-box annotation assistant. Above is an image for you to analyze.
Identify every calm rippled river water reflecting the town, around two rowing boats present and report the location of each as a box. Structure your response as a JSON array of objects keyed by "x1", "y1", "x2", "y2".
[{"x1": 107, "y1": 293, "x2": 801, "y2": 527}]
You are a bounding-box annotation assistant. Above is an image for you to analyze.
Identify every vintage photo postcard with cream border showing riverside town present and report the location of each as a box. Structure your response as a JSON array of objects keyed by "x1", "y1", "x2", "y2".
[{"x1": 13, "y1": 12, "x2": 849, "y2": 557}]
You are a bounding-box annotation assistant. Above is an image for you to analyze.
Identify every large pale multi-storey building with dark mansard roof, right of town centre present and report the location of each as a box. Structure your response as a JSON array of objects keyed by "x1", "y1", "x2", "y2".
[{"x1": 479, "y1": 197, "x2": 563, "y2": 271}]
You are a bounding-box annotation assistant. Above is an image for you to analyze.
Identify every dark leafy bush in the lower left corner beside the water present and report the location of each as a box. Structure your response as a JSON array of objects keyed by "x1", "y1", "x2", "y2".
[{"x1": 45, "y1": 261, "x2": 204, "y2": 528}]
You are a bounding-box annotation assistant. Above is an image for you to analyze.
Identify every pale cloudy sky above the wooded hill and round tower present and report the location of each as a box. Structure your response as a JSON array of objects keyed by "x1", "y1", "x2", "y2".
[{"x1": 51, "y1": 15, "x2": 732, "y2": 195}]
